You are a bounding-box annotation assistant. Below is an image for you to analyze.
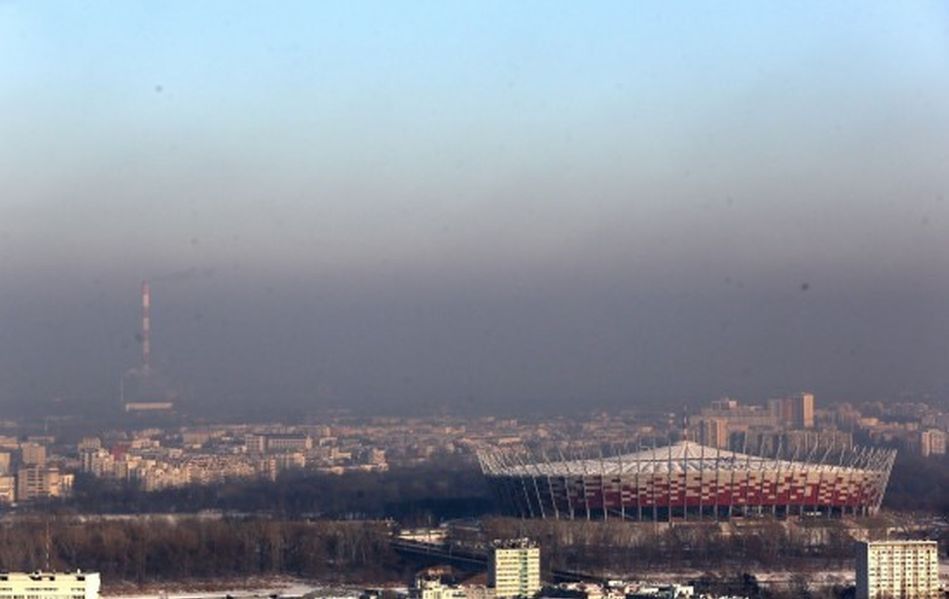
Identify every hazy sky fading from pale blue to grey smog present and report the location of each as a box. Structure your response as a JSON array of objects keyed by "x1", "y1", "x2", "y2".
[{"x1": 0, "y1": 0, "x2": 949, "y2": 411}]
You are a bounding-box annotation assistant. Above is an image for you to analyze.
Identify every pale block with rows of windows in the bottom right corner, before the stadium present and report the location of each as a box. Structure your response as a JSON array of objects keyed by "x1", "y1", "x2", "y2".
[{"x1": 857, "y1": 541, "x2": 940, "y2": 599}]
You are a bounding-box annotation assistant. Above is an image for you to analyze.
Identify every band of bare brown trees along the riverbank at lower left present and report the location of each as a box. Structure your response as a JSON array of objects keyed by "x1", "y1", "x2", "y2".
[{"x1": 0, "y1": 516, "x2": 405, "y2": 584}]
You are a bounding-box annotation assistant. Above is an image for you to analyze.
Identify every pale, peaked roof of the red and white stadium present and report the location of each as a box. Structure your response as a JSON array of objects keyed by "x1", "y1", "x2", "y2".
[{"x1": 478, "y1": 441, "x2": 888, "y2": 476}]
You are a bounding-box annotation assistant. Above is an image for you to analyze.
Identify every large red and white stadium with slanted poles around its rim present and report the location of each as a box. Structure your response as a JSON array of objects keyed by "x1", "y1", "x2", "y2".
[{"x1": 478, "y1": 441, "x2": 896, "y2": 521}]
